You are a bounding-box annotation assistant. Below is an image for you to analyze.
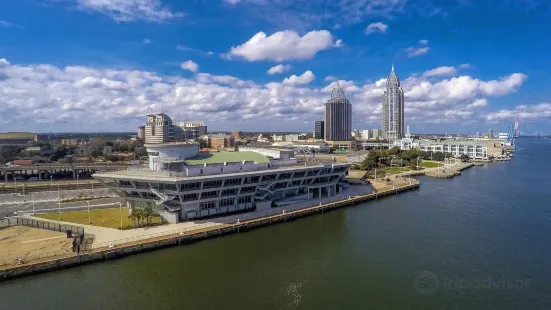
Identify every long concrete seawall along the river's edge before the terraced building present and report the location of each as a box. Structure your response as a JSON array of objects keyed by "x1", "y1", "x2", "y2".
[{"x1": 0, "y1": 179, "x2": 419, "y2": 281}]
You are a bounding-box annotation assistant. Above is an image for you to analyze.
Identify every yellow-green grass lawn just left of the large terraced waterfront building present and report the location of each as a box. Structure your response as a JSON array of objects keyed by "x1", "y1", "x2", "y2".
[{"x1": 36, "y1": 208, "x2": 161, "y2": 229}]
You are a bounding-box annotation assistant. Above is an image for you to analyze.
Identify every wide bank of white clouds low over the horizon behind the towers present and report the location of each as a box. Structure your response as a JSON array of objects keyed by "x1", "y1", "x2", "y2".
[{"x1": 0, "y1": 59, "x2": 536, "y2": 132}]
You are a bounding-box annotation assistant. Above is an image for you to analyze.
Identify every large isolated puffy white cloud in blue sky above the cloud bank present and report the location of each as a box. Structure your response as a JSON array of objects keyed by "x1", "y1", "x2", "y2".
[{"x1": 225, "y1": 30, "x2": 342, "y2": 61}]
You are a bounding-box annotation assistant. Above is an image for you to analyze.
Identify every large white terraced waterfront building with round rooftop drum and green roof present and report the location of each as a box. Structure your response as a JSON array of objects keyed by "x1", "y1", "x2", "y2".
[{"x1": 93, "y1": 143, "x2": 349, "y2": 223}]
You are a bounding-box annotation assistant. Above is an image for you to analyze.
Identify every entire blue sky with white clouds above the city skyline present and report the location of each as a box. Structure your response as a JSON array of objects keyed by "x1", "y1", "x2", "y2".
[{"x1": 0, "y1": 0, "x2": 551, "y2": 133}]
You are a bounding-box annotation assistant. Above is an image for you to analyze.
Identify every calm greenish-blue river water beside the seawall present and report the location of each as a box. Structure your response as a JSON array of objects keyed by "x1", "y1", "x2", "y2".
[{"x1": 0, "y1": 139, "x2": 551, "y2": 310}]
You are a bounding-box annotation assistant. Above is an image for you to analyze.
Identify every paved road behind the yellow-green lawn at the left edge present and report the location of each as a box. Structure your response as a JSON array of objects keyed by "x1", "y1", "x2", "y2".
[{"x1": 0, "y1": 198, "x2": 120, "y2": 219}]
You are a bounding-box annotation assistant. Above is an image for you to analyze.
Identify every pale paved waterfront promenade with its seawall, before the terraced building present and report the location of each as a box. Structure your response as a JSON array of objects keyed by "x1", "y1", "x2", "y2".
[{"x1": 0, "y1": 179, "x2": 419, "y2": 279}]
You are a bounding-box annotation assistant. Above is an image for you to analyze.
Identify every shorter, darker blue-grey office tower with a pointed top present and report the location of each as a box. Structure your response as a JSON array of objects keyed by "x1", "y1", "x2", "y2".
[{"x1": 324, "y1": 82, "x2": 352, "y2": 141}]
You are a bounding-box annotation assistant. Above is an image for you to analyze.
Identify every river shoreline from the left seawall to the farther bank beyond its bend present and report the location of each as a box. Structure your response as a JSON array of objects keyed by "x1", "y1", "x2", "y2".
[{"x1": 0, "y1": 163, "x2": 479, "y2": 281}]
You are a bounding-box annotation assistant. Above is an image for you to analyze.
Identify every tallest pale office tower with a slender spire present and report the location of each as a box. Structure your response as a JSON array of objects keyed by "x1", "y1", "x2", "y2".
[{"x1": 382, "y1": 65, "x2": 404, "y2": 142}]
